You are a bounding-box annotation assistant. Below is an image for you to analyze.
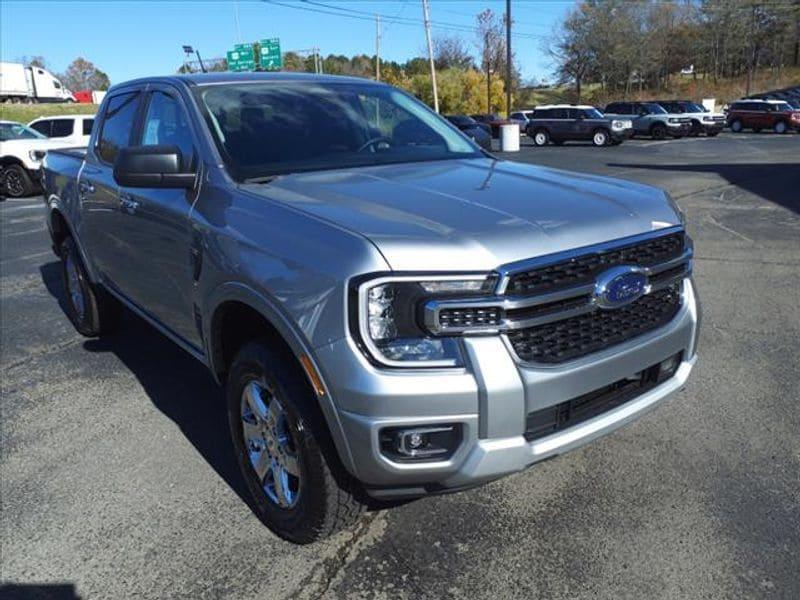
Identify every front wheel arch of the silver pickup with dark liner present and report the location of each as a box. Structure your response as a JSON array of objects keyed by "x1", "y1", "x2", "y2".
[{"x1": 205, "y1": 284, "x2": 357, "y2": 476}]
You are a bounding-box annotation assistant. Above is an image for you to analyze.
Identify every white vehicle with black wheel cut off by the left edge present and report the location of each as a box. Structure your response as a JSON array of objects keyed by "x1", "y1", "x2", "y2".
[{"x1": 0, "y1": 121, "x2": 65, "y2": 198}]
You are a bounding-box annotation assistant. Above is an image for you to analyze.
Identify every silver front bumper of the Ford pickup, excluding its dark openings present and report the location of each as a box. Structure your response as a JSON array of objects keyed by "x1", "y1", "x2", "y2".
[{"x1": 316, "y1": 279, "x2": 700, "y2": 498}]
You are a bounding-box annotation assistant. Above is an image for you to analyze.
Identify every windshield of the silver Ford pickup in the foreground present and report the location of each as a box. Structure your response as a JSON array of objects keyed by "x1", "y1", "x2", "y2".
[{"x1": 197, "y1": 81, "x2": 483, "y2": 181}]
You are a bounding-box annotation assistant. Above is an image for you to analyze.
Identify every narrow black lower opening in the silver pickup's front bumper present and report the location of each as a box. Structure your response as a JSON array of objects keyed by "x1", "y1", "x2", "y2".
[{"x1": 525, "y1": 353, "x2": 681, "y2": 442}]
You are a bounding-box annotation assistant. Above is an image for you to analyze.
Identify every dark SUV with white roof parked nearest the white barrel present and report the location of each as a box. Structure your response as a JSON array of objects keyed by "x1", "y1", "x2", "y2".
[{"x1": 525, "y1": 104, "x2": 633, "y2": 146}]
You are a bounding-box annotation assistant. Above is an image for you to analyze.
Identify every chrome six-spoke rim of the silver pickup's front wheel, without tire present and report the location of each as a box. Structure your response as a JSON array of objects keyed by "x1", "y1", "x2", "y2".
[{"x1": 241, "y1": 381, "x2": 300, "y2": 508}]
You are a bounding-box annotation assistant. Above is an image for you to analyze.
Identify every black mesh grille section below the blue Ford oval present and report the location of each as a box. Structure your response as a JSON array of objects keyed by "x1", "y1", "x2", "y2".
[{"x1": 508, "y1": 284, "x2": 681, "y2": 363}]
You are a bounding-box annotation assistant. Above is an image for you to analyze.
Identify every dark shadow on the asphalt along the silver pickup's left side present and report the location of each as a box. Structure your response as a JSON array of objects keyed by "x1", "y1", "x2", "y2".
[{"x1": 40, "y1": 262, "x2": 253, "y2": 510}]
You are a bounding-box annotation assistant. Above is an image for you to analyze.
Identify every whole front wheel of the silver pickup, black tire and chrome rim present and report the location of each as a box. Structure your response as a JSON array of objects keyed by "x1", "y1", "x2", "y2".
[{"x1": 226, "y1": 340, "x2": 365, "y2": 544}]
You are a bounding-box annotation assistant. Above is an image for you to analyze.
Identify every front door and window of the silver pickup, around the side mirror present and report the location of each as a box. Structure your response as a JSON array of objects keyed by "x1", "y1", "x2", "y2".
[{"x1": 119, "y1": 85, "x2": 202, "y2": 349}]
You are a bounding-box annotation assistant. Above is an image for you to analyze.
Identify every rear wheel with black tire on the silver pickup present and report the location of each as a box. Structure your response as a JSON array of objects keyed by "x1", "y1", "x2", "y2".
[{"x1": 60, "y1": 237, "x2": 122, "y2": 337}]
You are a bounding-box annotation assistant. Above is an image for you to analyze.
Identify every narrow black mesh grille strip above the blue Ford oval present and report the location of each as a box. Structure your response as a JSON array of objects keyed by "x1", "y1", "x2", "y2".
[{"x1": 506, "y1": 233, "x2": 684, "y2": 296}]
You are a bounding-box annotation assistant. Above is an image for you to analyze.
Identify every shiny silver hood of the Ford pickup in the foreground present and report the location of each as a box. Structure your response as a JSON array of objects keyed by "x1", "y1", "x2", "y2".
[{"x1": 242, "y1": 158, "x2": 680, "y2": 271}]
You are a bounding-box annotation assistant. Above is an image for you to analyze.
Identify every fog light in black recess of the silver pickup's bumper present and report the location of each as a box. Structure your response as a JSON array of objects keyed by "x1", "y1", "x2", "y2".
[{"x1": 380, "y1": 425, "x2": 461, "y2": 460}]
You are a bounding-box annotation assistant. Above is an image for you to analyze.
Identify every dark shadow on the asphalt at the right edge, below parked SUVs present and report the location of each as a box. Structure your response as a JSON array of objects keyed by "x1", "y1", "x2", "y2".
[{"x1": 607, "y1": 162, "x2": 800, "y2": 214}]
